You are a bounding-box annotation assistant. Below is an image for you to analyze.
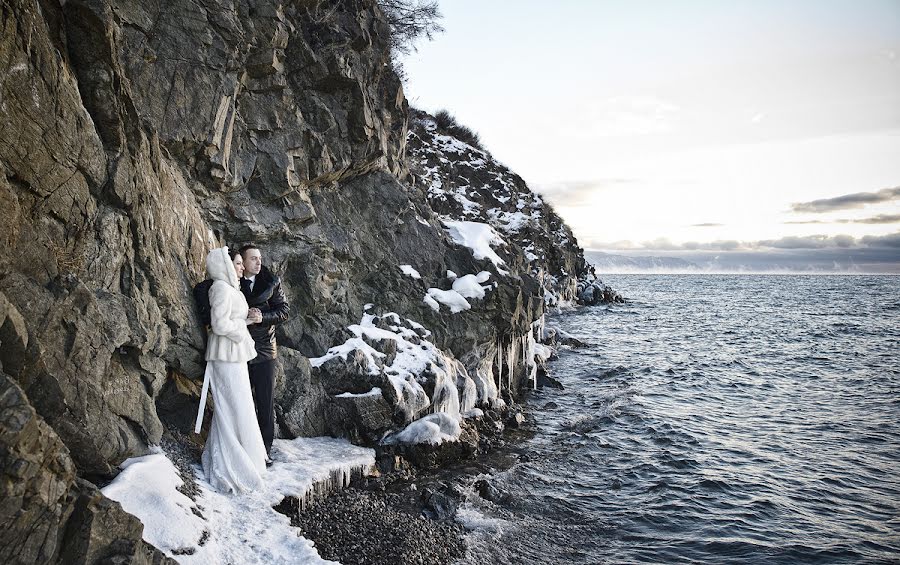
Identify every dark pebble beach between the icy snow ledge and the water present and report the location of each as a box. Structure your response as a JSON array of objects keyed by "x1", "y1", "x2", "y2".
[{"x1": 276, "y1": 407, "x2": 531, "y2": 565}]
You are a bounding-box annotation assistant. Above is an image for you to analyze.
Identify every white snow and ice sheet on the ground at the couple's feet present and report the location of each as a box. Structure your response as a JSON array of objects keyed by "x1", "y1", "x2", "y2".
[{"x1": 103, "y1": 437, "x2": 375, "y2": 565}]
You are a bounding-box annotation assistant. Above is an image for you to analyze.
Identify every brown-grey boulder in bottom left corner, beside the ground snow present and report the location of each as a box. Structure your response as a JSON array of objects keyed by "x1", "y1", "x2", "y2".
[{"x1": 0, "y1": 373, "x2": 174, "y2": 564}]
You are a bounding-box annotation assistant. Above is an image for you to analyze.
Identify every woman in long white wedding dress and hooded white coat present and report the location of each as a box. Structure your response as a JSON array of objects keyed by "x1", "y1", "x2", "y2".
[{"x1": 198, "y1": 247, "x2": 266, "y2": 493}]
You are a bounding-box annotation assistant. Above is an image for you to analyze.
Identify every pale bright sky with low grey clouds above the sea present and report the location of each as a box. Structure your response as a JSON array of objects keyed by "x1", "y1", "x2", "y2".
[{"x1": 404, "y1": 0, "x2": 900, "y2": 271}]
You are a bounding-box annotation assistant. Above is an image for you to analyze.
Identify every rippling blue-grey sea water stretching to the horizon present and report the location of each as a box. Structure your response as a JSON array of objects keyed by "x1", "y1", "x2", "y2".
[{"x1": 459, "y1": 275, "x2": 900, "y2": 565}]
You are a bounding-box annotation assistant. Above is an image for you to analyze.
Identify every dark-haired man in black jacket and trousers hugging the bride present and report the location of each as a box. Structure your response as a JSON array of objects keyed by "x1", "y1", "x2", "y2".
[{"x1": 240, "y1": 244, "x2": 290, "y2": 460}]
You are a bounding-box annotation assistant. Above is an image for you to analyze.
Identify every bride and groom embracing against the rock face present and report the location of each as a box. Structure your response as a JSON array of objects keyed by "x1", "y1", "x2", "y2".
[{"x1": 195, "y1": 245, "x2": 289, "y2": 492}]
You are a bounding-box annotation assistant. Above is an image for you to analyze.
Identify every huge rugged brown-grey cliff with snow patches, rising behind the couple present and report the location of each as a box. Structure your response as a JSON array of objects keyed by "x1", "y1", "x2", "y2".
[{"x1": 0, "y1": 0, "x2": 612, "y2": 563}]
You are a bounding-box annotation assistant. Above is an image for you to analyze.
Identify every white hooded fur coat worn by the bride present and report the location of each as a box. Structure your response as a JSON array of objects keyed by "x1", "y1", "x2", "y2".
[{"x1": 206, "y1": 247, "x2": 256, "y2": 363}]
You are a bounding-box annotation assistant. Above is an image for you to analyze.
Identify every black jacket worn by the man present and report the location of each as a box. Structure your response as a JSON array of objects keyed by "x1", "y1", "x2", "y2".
[{"x1": 241, "y1": 266, "x2": 290, "y2": 365}]
